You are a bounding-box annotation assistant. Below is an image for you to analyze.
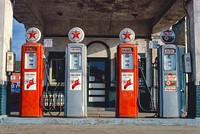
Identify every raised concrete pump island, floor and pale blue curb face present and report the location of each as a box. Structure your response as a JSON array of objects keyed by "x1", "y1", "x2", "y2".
[{"x1": 0, "y1": 109, "x2": 200, "y2": 126}]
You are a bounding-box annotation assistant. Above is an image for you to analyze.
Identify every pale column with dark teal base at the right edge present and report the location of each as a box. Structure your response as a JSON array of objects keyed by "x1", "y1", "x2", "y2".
[{"x1": 187, "y1": 0, "x2": 200, "y2": 117}]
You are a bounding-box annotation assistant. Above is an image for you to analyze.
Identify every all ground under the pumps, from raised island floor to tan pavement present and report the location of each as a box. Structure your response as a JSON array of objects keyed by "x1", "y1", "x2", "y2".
[{"x1": 0, "y1": 109, "x2": 200, "y2": 134}]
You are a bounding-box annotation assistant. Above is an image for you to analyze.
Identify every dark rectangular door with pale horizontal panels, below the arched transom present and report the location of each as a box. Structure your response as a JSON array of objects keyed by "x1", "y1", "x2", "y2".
[{"x1": 87, "y1": 58, "x2": 110, "y2": 107}]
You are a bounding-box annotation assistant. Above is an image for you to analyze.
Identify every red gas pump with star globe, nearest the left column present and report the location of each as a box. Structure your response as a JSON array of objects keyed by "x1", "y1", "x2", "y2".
[{"x1": 20, "y1": 27, "x2": 44, "y2": 117}]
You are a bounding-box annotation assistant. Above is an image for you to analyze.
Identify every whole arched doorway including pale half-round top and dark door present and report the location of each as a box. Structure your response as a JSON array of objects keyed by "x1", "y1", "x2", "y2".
[{"x1": 87, "y1": 41, "x2": 111, "y2": 107}]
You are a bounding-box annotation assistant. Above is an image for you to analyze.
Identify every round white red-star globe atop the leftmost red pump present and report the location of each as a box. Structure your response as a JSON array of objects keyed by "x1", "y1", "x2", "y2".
[{"x1": 26, "y1": 27, "x2": 41, "y2": 42}]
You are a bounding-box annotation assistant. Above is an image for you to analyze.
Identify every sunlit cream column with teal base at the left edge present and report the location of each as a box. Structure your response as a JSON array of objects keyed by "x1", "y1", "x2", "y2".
[{"x1": 0, "y1": 0, "x2": 13, "y2": 115}]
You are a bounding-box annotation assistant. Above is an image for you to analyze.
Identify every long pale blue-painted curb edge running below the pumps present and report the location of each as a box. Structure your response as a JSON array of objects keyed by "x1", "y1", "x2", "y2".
[{"x1": 0, "y1": 117, "x2": 200, "y2": 126}]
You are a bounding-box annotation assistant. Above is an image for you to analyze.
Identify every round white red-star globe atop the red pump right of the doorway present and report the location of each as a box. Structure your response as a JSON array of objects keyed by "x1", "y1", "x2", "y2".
[{"x1": 119, "y1": 28, "x2": 135, "y2": 42}]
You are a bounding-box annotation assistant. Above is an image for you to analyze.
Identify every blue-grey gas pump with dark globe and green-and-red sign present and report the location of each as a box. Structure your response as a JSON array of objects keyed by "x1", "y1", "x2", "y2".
[{"x1": 158, "y1": 30, "x2": 186, "y2": 117}]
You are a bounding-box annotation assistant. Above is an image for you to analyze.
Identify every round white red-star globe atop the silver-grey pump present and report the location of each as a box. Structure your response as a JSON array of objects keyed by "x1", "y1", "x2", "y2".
[{"x1": 68, "y1": 27, "x2": 84, "y2": 43}]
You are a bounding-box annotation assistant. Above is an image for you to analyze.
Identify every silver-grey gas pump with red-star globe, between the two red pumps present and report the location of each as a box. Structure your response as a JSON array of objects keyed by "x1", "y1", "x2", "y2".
[{"x1": 65, "y1": 27, "x2": 87, "y2": 117}]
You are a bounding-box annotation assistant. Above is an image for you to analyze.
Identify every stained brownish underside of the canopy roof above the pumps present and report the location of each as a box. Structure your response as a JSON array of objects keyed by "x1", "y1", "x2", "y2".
[{"x1": 13, "y1": 0, "x2": 185, "y2": 38}]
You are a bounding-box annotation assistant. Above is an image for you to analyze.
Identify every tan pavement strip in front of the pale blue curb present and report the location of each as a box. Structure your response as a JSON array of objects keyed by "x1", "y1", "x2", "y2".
[{"x1": 0, "y1": 124, "x2": 200, "y2": 134}]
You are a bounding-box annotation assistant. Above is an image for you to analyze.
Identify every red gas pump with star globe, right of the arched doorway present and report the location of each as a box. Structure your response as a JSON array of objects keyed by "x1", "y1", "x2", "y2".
[{"x1": 116, "y1": 28, "x2": 138, "y2": 117}]
